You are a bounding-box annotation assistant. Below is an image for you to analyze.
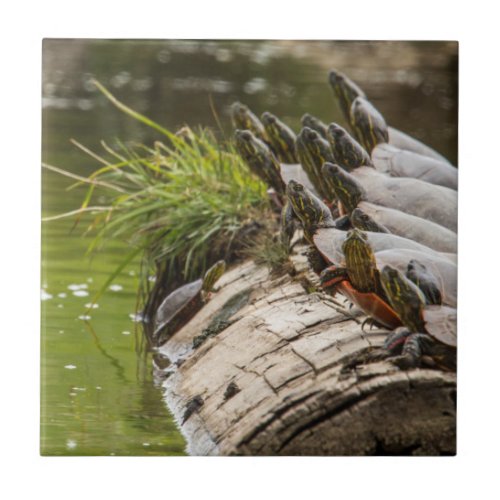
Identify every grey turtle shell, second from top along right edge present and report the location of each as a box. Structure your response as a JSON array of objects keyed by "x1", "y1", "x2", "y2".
[{"x1": 372, "y1": 144, "x2": 458, "y2": 190}]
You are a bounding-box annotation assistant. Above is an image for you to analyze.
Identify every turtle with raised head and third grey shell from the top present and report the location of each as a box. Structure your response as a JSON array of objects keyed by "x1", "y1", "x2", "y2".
[{"x1": 323, "y1": 163, "x2": 458, "y2": 232}]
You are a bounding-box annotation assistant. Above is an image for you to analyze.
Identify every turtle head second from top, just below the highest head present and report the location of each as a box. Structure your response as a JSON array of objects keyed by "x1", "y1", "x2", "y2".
[{"x1": 351, "y1": 97, "x2": 389, "y2": 153}]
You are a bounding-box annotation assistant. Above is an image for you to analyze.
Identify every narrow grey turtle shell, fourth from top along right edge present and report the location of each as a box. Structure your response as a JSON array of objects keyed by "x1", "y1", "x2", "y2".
[{"x1": 358, "y1": 201, "x2": 458, "y2": 253}]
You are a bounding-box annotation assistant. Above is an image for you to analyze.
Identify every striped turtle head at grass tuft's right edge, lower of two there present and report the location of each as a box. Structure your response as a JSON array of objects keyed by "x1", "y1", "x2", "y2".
[{"x1": 235, "y1": 130, "x2": 285, "y2": 195}]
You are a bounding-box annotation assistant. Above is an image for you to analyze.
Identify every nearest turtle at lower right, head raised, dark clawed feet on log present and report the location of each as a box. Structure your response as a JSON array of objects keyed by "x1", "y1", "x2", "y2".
[{"x1": 380, "y1": 266, "x2": 457, "y2": 370}]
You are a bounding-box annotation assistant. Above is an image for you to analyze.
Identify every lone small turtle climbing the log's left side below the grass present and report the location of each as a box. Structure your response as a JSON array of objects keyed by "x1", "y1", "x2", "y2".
[{"x1": 153, "y1": 260, "x2": 226, "y2": 345}]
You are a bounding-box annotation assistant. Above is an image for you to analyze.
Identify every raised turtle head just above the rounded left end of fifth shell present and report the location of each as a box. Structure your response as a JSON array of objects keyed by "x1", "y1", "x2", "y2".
[{"x1": 286, "y1": 179, "x2": 335, "y2": 236}]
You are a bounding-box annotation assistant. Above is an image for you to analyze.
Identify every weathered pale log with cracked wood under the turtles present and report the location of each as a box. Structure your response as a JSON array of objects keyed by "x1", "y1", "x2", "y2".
[{"x1": 157, "y1": 247, "x2": 456, "y2": 455}]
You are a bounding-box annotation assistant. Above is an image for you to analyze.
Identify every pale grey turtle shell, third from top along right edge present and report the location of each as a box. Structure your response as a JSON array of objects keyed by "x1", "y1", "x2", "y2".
[{"x1": 351, "y1": 167, "x2": 458, "y2": 232}]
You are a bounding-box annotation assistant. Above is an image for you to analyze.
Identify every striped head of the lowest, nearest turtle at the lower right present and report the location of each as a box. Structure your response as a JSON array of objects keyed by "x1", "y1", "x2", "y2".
[{"x1": 380, "y1": 265, "x2": 426, "y2": 332}]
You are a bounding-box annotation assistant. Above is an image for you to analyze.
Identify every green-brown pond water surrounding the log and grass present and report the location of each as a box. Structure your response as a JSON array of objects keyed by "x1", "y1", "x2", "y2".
[{"x1": 40, "y1": 40, "x2": 458, "y2": 455}]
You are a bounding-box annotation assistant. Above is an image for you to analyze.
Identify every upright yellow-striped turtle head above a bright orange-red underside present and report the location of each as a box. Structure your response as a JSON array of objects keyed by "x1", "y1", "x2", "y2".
[{"x1": 342, "y1": 229, "x2": 379, "y2": 292}]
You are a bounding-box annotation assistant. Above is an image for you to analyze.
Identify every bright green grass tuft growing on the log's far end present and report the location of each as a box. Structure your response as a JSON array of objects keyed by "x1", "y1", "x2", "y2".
[{"x1": 46, "y1": 82, "x2": 271, "y2": 315}]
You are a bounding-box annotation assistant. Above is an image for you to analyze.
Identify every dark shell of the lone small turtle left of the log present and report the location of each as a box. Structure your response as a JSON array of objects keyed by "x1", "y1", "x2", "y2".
[{"x1": 153, "y1": 279, "x2": 203, "y2": 343}]
